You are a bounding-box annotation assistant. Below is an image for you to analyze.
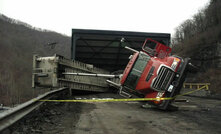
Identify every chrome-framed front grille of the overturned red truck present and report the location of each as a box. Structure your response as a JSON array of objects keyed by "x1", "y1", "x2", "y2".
[{"x1": 152, "y1": 66, "x2": 174, "y2": 91}]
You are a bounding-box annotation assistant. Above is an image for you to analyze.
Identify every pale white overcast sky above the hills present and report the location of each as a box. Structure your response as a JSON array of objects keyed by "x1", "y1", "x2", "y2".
[{"x1": 0, "y1": 0, "x2": 209, "y2": 36}]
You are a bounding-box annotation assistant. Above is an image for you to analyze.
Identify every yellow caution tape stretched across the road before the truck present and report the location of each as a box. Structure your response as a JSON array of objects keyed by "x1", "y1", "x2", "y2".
[{"x1": 39, "y1": 87, "x2": 207, "y2": 102}]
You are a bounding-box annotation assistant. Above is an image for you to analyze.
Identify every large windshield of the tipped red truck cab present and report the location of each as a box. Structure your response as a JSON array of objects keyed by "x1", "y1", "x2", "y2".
[{"x1": 124, "y1": 52, "x2": 150, "y2": 89}]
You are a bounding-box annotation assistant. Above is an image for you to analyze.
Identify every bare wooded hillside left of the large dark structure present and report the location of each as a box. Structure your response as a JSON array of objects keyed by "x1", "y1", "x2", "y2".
[{"x1": 0, "y1": 14, "x2": 71, "y2": 105}]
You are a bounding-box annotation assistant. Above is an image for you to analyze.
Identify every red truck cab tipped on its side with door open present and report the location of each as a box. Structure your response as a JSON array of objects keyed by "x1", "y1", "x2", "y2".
[{"x1": 120, "y1": 39, "x2": 189, "y2": 110}]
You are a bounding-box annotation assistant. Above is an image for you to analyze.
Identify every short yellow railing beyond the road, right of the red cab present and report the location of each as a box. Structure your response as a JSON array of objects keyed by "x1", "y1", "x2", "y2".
[{"x1": 183, "y1": 83, "x2": 210, "y2": 90}]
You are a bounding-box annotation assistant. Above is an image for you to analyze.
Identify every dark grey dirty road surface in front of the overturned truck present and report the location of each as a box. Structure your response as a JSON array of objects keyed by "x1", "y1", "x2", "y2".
[{"x1": 8, "y1": 93, "x2": 221, "y2": 134}]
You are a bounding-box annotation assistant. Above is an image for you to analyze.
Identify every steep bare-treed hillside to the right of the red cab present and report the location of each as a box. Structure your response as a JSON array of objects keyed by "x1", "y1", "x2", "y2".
[{"x1": 172, "y1": 0, "x2": 221, "y2": 94}]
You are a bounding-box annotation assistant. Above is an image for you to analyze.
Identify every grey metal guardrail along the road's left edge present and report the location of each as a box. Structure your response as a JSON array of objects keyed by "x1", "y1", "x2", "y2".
[{"x1": 0, "y1": 88, "x2": 68, "y2": 133}]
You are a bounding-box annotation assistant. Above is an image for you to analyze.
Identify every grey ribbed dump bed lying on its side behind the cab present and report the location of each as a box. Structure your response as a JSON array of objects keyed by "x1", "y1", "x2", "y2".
[{"x1": 32, "y1": 55, "x2": 109, "y2": 92}]
